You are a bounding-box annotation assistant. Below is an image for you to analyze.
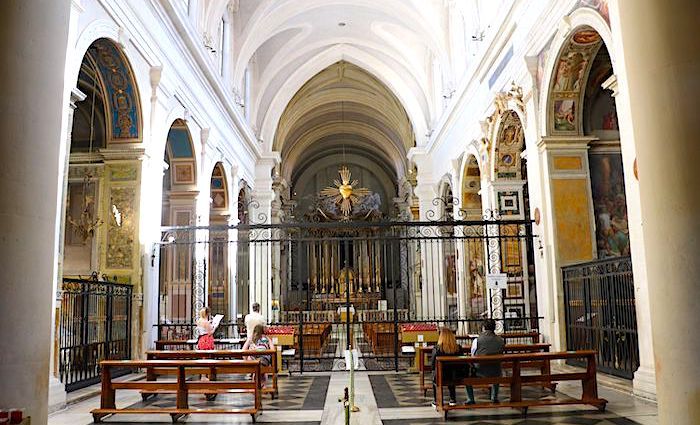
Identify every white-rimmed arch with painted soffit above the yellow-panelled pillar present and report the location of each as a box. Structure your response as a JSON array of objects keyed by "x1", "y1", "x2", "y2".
[{"x1": 539, "y1": 7, "x2": 617, "y2": 136}]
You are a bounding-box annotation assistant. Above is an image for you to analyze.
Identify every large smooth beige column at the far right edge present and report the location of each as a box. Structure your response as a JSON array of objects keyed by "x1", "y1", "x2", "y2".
[{"x1": 610, "y1": 0, "x2": 700, "y2": 418}]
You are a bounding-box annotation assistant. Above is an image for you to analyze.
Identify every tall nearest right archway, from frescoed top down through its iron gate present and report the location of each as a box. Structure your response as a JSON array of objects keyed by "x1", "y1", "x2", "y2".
[{"x1": 545, "y1": 26, "x2": 639, "y2": 378}]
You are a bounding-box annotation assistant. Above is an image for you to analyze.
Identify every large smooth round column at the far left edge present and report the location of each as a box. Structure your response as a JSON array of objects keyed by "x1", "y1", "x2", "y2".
[{"x1": 0, "y1": 0, "x2": 71, "y2": 425}]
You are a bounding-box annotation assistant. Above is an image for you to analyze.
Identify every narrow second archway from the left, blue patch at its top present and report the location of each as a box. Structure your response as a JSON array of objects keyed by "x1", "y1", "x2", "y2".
[{"x1": 158, "y1": 119, "x2": 198, "y2": 339}]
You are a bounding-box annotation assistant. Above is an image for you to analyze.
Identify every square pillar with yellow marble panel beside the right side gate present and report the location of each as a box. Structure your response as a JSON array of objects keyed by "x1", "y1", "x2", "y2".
[{"x1": 538, "y1": 137, "x2": 596, "y2": 351}]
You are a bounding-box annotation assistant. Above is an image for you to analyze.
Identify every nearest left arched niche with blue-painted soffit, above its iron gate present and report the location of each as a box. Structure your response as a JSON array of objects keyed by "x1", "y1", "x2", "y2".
[{"x1": 61, "y1": 38, "x2": 142, "y2": 282}]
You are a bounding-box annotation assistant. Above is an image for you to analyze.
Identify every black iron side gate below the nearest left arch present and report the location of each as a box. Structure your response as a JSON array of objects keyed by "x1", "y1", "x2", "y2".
[{"x1": 58, "y1": 279, "x2": 132, "y2": 391}]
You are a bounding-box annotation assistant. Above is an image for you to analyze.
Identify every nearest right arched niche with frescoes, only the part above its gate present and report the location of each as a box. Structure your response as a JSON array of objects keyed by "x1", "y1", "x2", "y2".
[{"x1": 547, "y1": 26, "x2": 630, "y2": 263}]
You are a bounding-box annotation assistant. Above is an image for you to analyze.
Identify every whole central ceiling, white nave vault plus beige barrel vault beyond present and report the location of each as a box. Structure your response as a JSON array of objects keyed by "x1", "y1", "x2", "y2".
[{"x1": 197, "y1": 0, "x2": 507, "y2": 171}]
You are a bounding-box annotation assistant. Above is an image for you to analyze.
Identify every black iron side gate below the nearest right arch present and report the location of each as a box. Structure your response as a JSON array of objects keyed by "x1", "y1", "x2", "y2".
[{"x1": 562, "y1": 257, "x2": 639, "y2": 379}]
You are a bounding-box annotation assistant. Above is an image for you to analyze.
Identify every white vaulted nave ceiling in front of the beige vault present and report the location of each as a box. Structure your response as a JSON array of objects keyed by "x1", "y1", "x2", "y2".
[{"x1": 227, "y1": 0, "x2": 452, "y2": 150}]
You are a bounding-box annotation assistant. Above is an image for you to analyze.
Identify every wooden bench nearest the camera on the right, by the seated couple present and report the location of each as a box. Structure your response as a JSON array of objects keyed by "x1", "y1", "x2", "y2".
[{"x1": 435, "y1": 350, "x2": 608, "y2": 419}]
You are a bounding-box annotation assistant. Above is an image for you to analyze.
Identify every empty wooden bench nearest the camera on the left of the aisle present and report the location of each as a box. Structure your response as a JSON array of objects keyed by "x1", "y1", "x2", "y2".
[{"x1": 91, "y1": 360, "x2": 262, "y2": 422}]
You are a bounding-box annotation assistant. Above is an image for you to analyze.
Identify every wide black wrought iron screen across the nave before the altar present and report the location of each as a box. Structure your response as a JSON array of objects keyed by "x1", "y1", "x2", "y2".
[{"x1": 154, "y1": 209, "x2": 539, "y2": 371}]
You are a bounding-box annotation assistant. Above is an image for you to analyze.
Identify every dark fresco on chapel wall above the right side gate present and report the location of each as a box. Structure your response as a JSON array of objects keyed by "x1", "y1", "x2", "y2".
[{"x1": 589, "y1": 153, "x2": 630, "y2": 258}]
